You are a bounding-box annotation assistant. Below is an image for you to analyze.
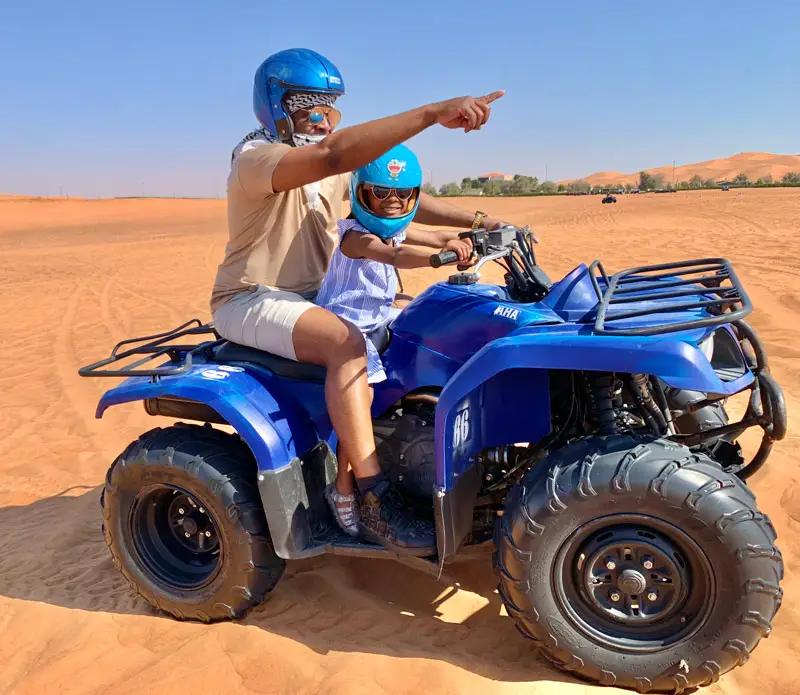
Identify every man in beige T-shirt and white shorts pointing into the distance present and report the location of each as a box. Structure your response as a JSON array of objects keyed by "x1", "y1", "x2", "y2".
[{"x1": 211, "y1": 49, "x2": 504, "y2": 555}]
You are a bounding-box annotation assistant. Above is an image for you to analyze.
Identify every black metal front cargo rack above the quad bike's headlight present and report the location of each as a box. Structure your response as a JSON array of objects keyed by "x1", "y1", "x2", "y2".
[{"x1": 589, "y1": 258, "x2": 753, "y2": 336}]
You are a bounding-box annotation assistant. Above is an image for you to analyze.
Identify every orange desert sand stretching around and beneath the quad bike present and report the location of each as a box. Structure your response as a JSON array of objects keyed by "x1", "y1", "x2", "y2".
[{"x1": 0, "y1": 189, "x2": 800, "y2": 695}]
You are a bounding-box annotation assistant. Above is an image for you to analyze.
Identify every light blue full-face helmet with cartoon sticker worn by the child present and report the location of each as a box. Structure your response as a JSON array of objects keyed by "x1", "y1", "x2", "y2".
[{"x1": 350, "y1": 145, "x2": 422, "y2": 239}]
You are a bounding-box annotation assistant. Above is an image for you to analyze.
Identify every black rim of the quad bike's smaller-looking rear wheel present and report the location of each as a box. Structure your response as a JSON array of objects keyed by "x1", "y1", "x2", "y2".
[{"x1": 129, "y1": 485, "x2": 222, "y2": 590}]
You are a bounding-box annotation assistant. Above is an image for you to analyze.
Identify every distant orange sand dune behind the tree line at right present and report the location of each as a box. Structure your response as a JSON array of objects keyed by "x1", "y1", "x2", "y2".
[{"x1": 562, "y1": 152, "x2": 800, "y2": 186}]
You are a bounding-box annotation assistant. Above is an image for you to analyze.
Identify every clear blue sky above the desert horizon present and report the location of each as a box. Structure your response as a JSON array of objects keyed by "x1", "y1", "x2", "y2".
[{"x1": 0, "y1": 0, "x2": 800, "y2": 197}]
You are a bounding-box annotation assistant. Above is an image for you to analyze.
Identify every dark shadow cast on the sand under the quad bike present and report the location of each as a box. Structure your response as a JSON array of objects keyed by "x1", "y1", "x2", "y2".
[{"x1": 0, "y1": 487, "x2": 575, "y2": 682}]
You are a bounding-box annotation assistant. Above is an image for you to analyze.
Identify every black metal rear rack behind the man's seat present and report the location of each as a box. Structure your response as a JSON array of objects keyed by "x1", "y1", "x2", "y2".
[{"x1": 78, "y1": 319, "x2": 225, "y2": 380}]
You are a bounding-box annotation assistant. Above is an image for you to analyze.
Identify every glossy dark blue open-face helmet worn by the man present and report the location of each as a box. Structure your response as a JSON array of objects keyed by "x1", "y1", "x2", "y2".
[{"x1": 253, "y1": 48, "x2": 344, "y2": 141}]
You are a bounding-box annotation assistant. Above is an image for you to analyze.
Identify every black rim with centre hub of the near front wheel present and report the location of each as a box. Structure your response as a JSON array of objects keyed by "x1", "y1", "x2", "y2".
[{"x1": 554, "y1": 515, "x2": 715, "y2": 651}]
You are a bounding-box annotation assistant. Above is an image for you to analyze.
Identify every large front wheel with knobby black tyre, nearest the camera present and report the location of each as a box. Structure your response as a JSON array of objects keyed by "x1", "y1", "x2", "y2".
[{"x1": 496, "y1": 436, "x2": 783, "y2": 693}]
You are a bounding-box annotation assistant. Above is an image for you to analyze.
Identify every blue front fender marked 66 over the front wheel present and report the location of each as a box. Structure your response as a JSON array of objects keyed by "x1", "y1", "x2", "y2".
[{"x1": 436, "y1": 326, "x2": 754, "y2": 490}]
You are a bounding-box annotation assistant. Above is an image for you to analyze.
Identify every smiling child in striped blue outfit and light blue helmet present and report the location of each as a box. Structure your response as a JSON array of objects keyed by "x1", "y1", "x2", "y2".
[{"x1": 316, "y1": 145, "x2": 472, "y2": 536}]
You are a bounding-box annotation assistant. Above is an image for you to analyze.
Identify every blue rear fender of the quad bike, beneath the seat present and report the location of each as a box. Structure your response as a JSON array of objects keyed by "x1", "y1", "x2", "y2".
[{"x1": 96, "y1": 364, "x2": 318, "y2": 472}]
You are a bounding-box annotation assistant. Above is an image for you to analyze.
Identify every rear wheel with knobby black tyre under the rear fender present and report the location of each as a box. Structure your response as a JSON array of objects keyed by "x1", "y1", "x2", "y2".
[{"x1": 101, "y1": 424, "x2": 284, "y2": 622}]
